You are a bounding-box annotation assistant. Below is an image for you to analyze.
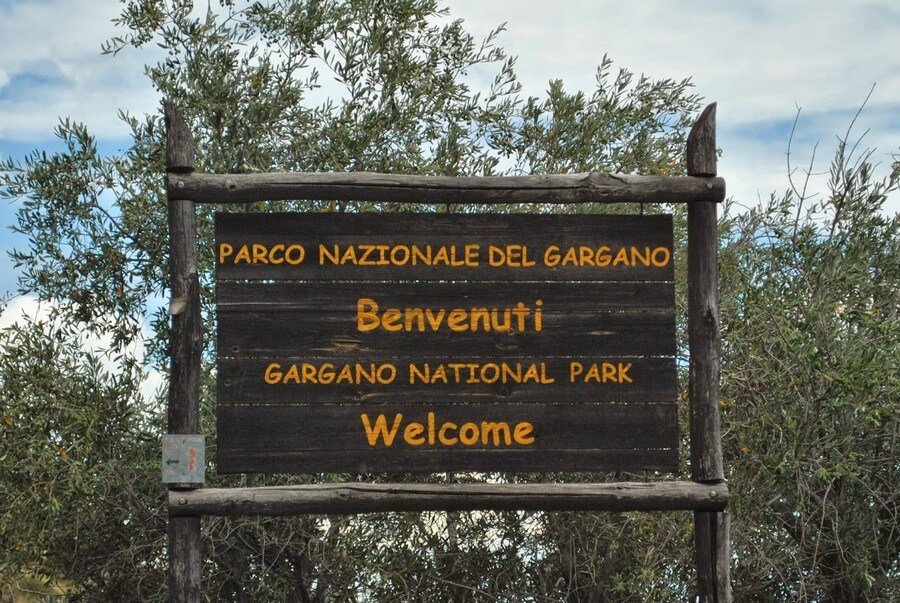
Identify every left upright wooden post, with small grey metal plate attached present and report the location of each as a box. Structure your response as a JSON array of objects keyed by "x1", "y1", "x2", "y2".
[{"x1": 163, "y1": 101, "x2": 203, "y2": 603}]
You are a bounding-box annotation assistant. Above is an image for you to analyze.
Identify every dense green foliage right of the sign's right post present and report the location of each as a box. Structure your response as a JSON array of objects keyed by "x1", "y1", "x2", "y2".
[{"x1": 721, "y1": 121, "x2": 900, "y2": 601}]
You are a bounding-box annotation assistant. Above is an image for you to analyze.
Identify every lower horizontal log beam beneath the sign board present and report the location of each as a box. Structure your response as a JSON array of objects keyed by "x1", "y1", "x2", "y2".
[{"x1": 169, "y1": 481, "x2": 728, "y2": 516}]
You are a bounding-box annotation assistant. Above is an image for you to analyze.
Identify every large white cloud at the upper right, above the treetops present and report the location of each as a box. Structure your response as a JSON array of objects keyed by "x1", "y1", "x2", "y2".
[{"x1": 450, "y1": 0, "x2": 900, "y2": 122}]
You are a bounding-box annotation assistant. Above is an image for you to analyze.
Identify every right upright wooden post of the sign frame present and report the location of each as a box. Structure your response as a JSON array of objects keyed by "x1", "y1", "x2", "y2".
[{"x1": 687, "y1": 103, "x2": 731, "y2": 603}]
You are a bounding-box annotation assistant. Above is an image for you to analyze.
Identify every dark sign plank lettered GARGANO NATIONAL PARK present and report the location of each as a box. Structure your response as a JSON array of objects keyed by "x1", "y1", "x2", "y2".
[{"x1": 217, "y1": 356, "x2": 677, "y2": 405}]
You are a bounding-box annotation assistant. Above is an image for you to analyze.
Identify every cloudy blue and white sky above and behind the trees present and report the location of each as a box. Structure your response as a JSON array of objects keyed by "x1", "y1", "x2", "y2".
[{"x1": 0, "y1": 0, "x2": 900, "y2": 302}]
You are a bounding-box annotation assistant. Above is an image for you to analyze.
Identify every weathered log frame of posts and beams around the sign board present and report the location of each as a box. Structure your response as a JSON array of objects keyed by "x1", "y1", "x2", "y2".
[{"x1": 164, "y1": 102, "x2": 731, "y2": 602}]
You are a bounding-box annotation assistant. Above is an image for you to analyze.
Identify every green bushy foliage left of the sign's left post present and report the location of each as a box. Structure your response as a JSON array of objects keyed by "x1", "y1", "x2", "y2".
[{"x1": 0, "y1": 320, "x2": 166, "y2": 600}]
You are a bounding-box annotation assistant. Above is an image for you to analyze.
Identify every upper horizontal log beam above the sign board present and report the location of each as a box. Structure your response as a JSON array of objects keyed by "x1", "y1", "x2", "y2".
[{"x1": 168, "y1": 172, "x2": 725, "y2": 204}]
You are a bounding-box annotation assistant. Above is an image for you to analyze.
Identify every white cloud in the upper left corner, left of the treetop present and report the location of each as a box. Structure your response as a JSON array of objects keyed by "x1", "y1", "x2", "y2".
[{"x1": 0, "y1": 0, "x2": 159, "y2": 142}]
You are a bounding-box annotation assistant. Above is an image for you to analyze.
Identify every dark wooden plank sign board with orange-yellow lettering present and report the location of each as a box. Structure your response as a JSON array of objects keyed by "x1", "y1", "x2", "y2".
[{"x1": 215, "y1": 213, "x2": 678, "y2": 473}]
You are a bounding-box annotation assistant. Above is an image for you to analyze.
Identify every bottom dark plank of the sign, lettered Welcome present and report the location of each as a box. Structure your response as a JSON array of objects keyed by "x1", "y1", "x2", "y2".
[{"x1": 217, "y1": 403, "x2": 678, "y2": 473}]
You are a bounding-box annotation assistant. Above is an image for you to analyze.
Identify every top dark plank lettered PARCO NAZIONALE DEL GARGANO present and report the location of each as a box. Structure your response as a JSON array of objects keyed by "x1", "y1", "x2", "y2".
[{"x1": 216, "y1": 213, "x2": 674, "y2": 281}]
